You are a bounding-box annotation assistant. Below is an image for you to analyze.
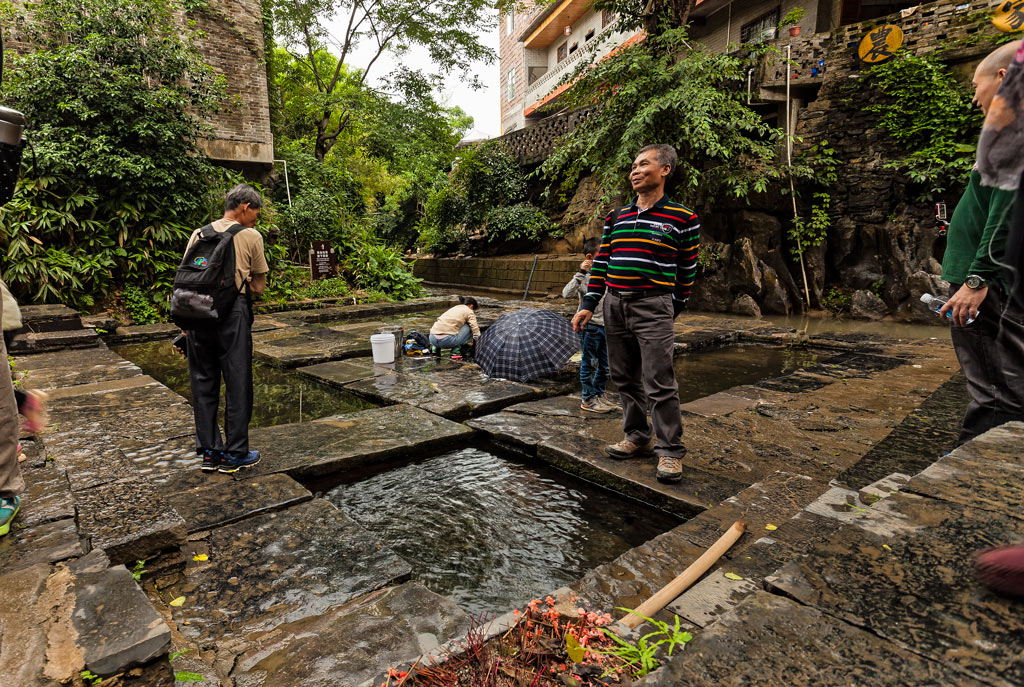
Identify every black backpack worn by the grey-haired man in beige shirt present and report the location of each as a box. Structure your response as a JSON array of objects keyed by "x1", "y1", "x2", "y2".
[{"x1": 171, "y1": 224, "x2": 246, "y2": 330}]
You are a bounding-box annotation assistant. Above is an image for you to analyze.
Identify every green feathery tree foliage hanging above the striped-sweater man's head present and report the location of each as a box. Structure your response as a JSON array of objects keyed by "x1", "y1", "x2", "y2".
[{"x1": 539, "y1": 29, "x2": 784, "y2": 209}]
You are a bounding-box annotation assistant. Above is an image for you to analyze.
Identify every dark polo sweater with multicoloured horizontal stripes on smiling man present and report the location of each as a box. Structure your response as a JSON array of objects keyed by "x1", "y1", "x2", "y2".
[{"x1": 582, "y1": 196, "x2": 700, "y2": 311}]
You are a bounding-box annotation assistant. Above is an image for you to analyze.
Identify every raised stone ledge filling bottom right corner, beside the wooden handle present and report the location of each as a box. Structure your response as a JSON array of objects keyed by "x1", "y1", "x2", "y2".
[{"x1": 640, "y1": 423, "x2": 1024, "y2": 687}]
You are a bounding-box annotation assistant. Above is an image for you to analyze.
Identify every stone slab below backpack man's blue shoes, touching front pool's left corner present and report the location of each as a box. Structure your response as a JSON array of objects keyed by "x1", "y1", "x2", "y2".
[{"x1": 167, "y1": 472, "x2": 312, "y2": 533}]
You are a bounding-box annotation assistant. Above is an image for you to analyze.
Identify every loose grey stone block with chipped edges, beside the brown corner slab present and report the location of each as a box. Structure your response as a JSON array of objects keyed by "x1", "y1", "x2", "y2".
[{"x1": 72, "y1": 565, "x2": 171, "y2": 676}]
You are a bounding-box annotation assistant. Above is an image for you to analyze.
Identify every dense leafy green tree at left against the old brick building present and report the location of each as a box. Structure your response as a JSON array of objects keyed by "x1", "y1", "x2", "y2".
[{"x1": 0, "y1": 0, "x2": 223, "y2": 305}]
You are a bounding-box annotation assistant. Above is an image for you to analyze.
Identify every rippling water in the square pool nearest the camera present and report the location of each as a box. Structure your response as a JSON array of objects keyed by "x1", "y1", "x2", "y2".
[{"x1": 328, "y1": 448, "x2": 679, "y2": 614}]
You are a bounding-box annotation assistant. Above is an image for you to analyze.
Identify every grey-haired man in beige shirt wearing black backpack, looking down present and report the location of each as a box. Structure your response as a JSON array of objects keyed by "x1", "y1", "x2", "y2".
[{"x1": 171, "y1": 183, "x2": 270, "y2": 473}]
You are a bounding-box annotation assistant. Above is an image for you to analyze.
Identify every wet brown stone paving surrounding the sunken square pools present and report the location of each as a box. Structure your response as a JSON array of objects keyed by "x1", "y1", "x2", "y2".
[{"x1": 0, "y1": 297, "x2": 1024, "y2": 687}]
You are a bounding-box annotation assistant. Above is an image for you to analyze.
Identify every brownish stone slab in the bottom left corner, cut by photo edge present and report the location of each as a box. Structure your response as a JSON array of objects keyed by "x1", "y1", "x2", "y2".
[{"x1": 0, "y1": 563, "x2": 50, "y2": 686}]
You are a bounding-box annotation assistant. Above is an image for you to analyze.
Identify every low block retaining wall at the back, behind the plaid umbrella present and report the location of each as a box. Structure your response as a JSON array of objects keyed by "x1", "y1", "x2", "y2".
[{"x1": 414, "y1": 256, "x2": 580, "y2": 295}]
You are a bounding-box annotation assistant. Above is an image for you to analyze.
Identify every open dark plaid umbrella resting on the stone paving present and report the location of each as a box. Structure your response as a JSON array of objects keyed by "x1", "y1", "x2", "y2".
[{"x1": 475, "y1": 308, "x2": 580, "y2": 382}]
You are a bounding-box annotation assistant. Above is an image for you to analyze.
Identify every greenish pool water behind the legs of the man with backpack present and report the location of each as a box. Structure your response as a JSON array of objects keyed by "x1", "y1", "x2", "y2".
[{"x1": 114, "y1": 341, "x2": 374, "y2": 427}]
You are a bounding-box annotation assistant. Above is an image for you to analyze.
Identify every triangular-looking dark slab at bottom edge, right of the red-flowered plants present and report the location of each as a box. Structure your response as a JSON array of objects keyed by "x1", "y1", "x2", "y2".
[{"x1": 639, "y1": 592, "x2": 983, "y2": 687}]
